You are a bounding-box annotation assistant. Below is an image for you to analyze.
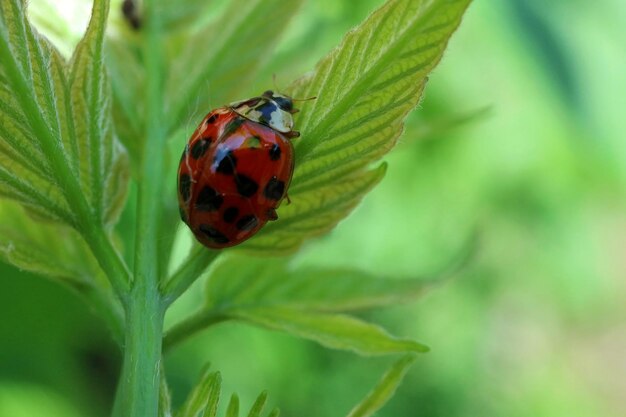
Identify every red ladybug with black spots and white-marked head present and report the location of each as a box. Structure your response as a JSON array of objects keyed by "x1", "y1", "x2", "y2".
[{"x1": 178, "y1": 91, "x2": 300, "y2": 249}]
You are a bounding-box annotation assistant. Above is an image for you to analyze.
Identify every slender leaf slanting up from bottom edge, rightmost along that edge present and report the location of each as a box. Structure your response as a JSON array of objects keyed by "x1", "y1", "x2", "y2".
[{"x1": 348, "y1": 354, "x2": 416, "y2": 417}]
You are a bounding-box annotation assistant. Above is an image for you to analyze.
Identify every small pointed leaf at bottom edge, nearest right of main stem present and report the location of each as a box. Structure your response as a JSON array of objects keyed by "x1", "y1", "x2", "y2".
[{"x1": 176, "y1": 367, "x2": 222, "y2": 417}]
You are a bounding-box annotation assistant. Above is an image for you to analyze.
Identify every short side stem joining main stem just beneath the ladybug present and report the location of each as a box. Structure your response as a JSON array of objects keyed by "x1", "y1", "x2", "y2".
[{"x1": 161, "y1": 248, "x2": 220, "y2": 306}]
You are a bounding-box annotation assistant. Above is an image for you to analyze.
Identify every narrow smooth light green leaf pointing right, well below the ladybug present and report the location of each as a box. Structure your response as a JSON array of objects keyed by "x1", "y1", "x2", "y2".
[{"x1": 228, "y1": 307, "x2": 428, "y2": 356}]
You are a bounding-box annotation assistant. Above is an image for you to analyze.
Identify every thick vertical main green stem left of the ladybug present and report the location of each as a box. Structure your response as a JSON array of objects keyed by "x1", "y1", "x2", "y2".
[{"x1": 114, "y1": 0, "x2": 166, "y2": 417}]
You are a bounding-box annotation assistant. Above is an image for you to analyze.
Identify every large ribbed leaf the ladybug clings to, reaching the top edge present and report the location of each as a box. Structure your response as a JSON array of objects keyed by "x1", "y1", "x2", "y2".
[{"x1": 241, "y1": 0, "x2": 470, "y2": 252}]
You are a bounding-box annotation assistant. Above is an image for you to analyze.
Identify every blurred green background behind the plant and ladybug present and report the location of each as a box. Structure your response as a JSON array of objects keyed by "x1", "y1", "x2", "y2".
[{"x1": 0, "y1": 0, "x2": 626, "y2": 417}]
